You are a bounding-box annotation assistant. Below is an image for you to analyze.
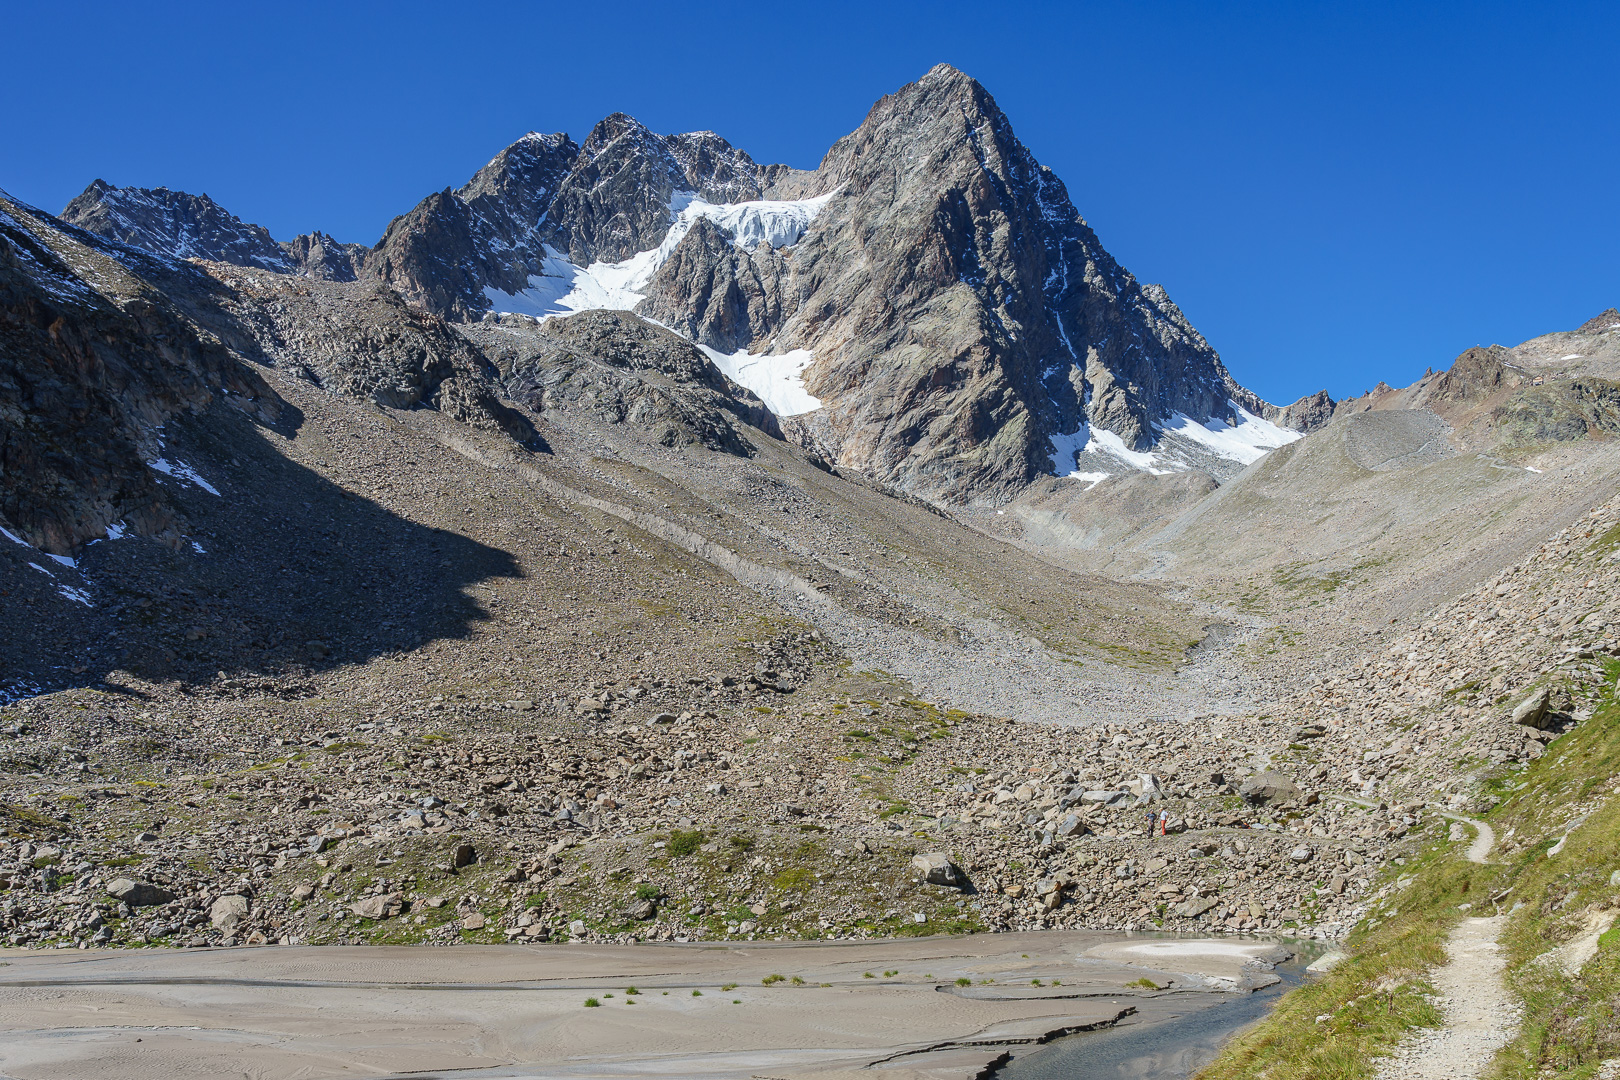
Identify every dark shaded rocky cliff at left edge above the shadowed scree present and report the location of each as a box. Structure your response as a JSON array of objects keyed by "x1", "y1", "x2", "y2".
[{"x1": 0, "y1": 193, "x2": 282, "y2": 554}]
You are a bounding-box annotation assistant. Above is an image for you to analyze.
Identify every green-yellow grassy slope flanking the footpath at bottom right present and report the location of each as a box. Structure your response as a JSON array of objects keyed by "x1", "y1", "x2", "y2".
[{"x1": 1199, "y1": 664, "x2": 1620, "y2": 1080}]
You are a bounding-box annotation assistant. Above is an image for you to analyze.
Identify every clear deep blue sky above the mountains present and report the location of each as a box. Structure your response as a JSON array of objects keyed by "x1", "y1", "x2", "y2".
[{"x1": 0, "y1": 0, "x2": 1620, "y2": 402}]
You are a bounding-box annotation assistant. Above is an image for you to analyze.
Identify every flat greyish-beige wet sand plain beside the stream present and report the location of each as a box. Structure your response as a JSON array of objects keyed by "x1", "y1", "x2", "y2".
[{"x1": 0, "y1": 931, "x2": 1296, "y2": 1080}]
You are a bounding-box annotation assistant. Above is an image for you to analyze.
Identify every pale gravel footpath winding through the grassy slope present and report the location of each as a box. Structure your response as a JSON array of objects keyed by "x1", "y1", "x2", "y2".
[{"x1": 1379, "y1": 919, "x2": 1520, "y2": 1080}]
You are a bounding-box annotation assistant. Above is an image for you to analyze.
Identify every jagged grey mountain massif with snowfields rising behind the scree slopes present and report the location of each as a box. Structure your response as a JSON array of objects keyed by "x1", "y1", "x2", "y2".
[{"x1": 57, "y1": 63, "x2": 1332, "y2": 502}]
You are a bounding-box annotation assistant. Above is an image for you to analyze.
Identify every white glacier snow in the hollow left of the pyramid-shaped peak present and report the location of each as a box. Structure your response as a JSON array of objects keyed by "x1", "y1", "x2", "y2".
[{"x1": 484, "y1": 191, "x2": 833, "y2": 416}]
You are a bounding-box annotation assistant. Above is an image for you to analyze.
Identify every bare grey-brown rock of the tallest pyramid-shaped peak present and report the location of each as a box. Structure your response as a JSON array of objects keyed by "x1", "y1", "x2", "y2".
[{"x1": 640, "y1": 65, "x2": 1277, "y2": 499}]
